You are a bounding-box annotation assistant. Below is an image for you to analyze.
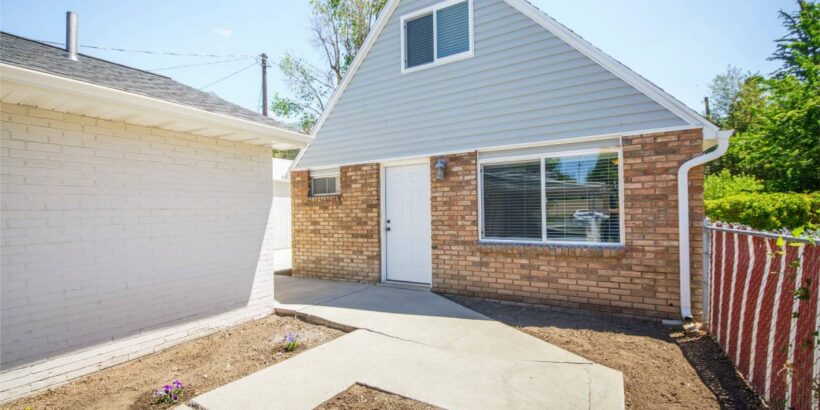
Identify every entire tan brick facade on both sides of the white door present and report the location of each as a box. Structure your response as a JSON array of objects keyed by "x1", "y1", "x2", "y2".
[{"x1": 293, "y1": 129, "x2": 704, "y2": 318}]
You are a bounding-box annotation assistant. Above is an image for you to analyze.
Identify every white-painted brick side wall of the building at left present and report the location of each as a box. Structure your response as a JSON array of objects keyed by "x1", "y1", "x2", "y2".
[{"x1": 0, "y1": 104, "x2": 274, "y2": 399}]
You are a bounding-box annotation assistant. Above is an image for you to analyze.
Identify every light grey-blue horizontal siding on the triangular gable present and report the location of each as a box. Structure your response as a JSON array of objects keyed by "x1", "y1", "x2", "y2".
[{"x1": 297, "y1": 0, "x2": 687, "y2": 169}]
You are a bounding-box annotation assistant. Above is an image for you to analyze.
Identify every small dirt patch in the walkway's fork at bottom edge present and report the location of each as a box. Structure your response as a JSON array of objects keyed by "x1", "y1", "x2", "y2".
[{"x1": 316, "y1": 384, "x2": 439, "y2": 410}]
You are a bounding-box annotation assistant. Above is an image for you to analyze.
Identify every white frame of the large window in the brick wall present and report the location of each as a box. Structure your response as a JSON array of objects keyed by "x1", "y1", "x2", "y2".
[{"x1": 476, "y1": 147, "x2": 626, "y2": 247}]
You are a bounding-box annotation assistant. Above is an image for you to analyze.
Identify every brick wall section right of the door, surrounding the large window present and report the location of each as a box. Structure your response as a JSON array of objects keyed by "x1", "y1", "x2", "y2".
[{"x1": 430, "y1": 130, "x2": 703, "y2": 318}]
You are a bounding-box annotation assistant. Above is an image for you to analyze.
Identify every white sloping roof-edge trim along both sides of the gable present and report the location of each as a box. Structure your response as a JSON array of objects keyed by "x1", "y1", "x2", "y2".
[{"x1": 294, "y1": 0, "x2": 718, "y2": 169}]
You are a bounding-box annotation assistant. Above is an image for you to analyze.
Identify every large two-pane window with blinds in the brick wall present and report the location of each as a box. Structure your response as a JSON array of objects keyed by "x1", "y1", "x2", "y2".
[{"x1": 480, "y1": 150, "x2": 623, "y2": 244}]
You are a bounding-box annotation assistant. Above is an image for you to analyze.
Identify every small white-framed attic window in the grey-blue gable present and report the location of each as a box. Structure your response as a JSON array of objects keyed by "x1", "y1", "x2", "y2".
[{"x1": 401, "y1": 0, "x2": 473, "y2": 73}]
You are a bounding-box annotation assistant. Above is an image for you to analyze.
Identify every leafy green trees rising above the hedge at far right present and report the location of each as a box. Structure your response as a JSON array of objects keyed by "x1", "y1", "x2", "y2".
[{"x1": 707, "y1": 1, "x2": 820, "y2": 192}]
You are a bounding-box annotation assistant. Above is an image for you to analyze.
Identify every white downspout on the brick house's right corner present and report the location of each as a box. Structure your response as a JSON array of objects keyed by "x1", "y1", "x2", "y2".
[{"x1": 678, "y1": 130, "x2": 735, "y2": 320}]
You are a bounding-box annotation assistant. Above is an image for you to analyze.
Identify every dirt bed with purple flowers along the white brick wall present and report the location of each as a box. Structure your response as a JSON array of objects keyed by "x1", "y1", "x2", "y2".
[{"x1": 2, "y1": 315, "x2": 343, "y2": 410}]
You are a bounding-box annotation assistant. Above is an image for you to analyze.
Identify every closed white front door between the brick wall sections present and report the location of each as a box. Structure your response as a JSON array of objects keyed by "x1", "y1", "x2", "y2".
[{"x1": 384, "y1": 164, "x2": 433, "y2": 284}]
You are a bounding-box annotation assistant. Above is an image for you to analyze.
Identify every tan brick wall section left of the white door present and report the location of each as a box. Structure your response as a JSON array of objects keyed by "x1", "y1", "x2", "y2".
[{"x1": 291, "y1": 164, "x2": 381, "y2": 282}]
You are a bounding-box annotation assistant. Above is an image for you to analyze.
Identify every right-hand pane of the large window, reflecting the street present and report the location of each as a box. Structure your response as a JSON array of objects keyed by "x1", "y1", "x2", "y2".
[{"x1": 544, "y1": 153, "x2": 620, "y2": 243}]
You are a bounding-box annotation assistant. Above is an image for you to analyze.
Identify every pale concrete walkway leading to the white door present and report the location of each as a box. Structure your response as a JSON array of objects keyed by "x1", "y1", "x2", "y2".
[{"x1": 187, "y1": 276, "x2": 624, "y2": 410}]
